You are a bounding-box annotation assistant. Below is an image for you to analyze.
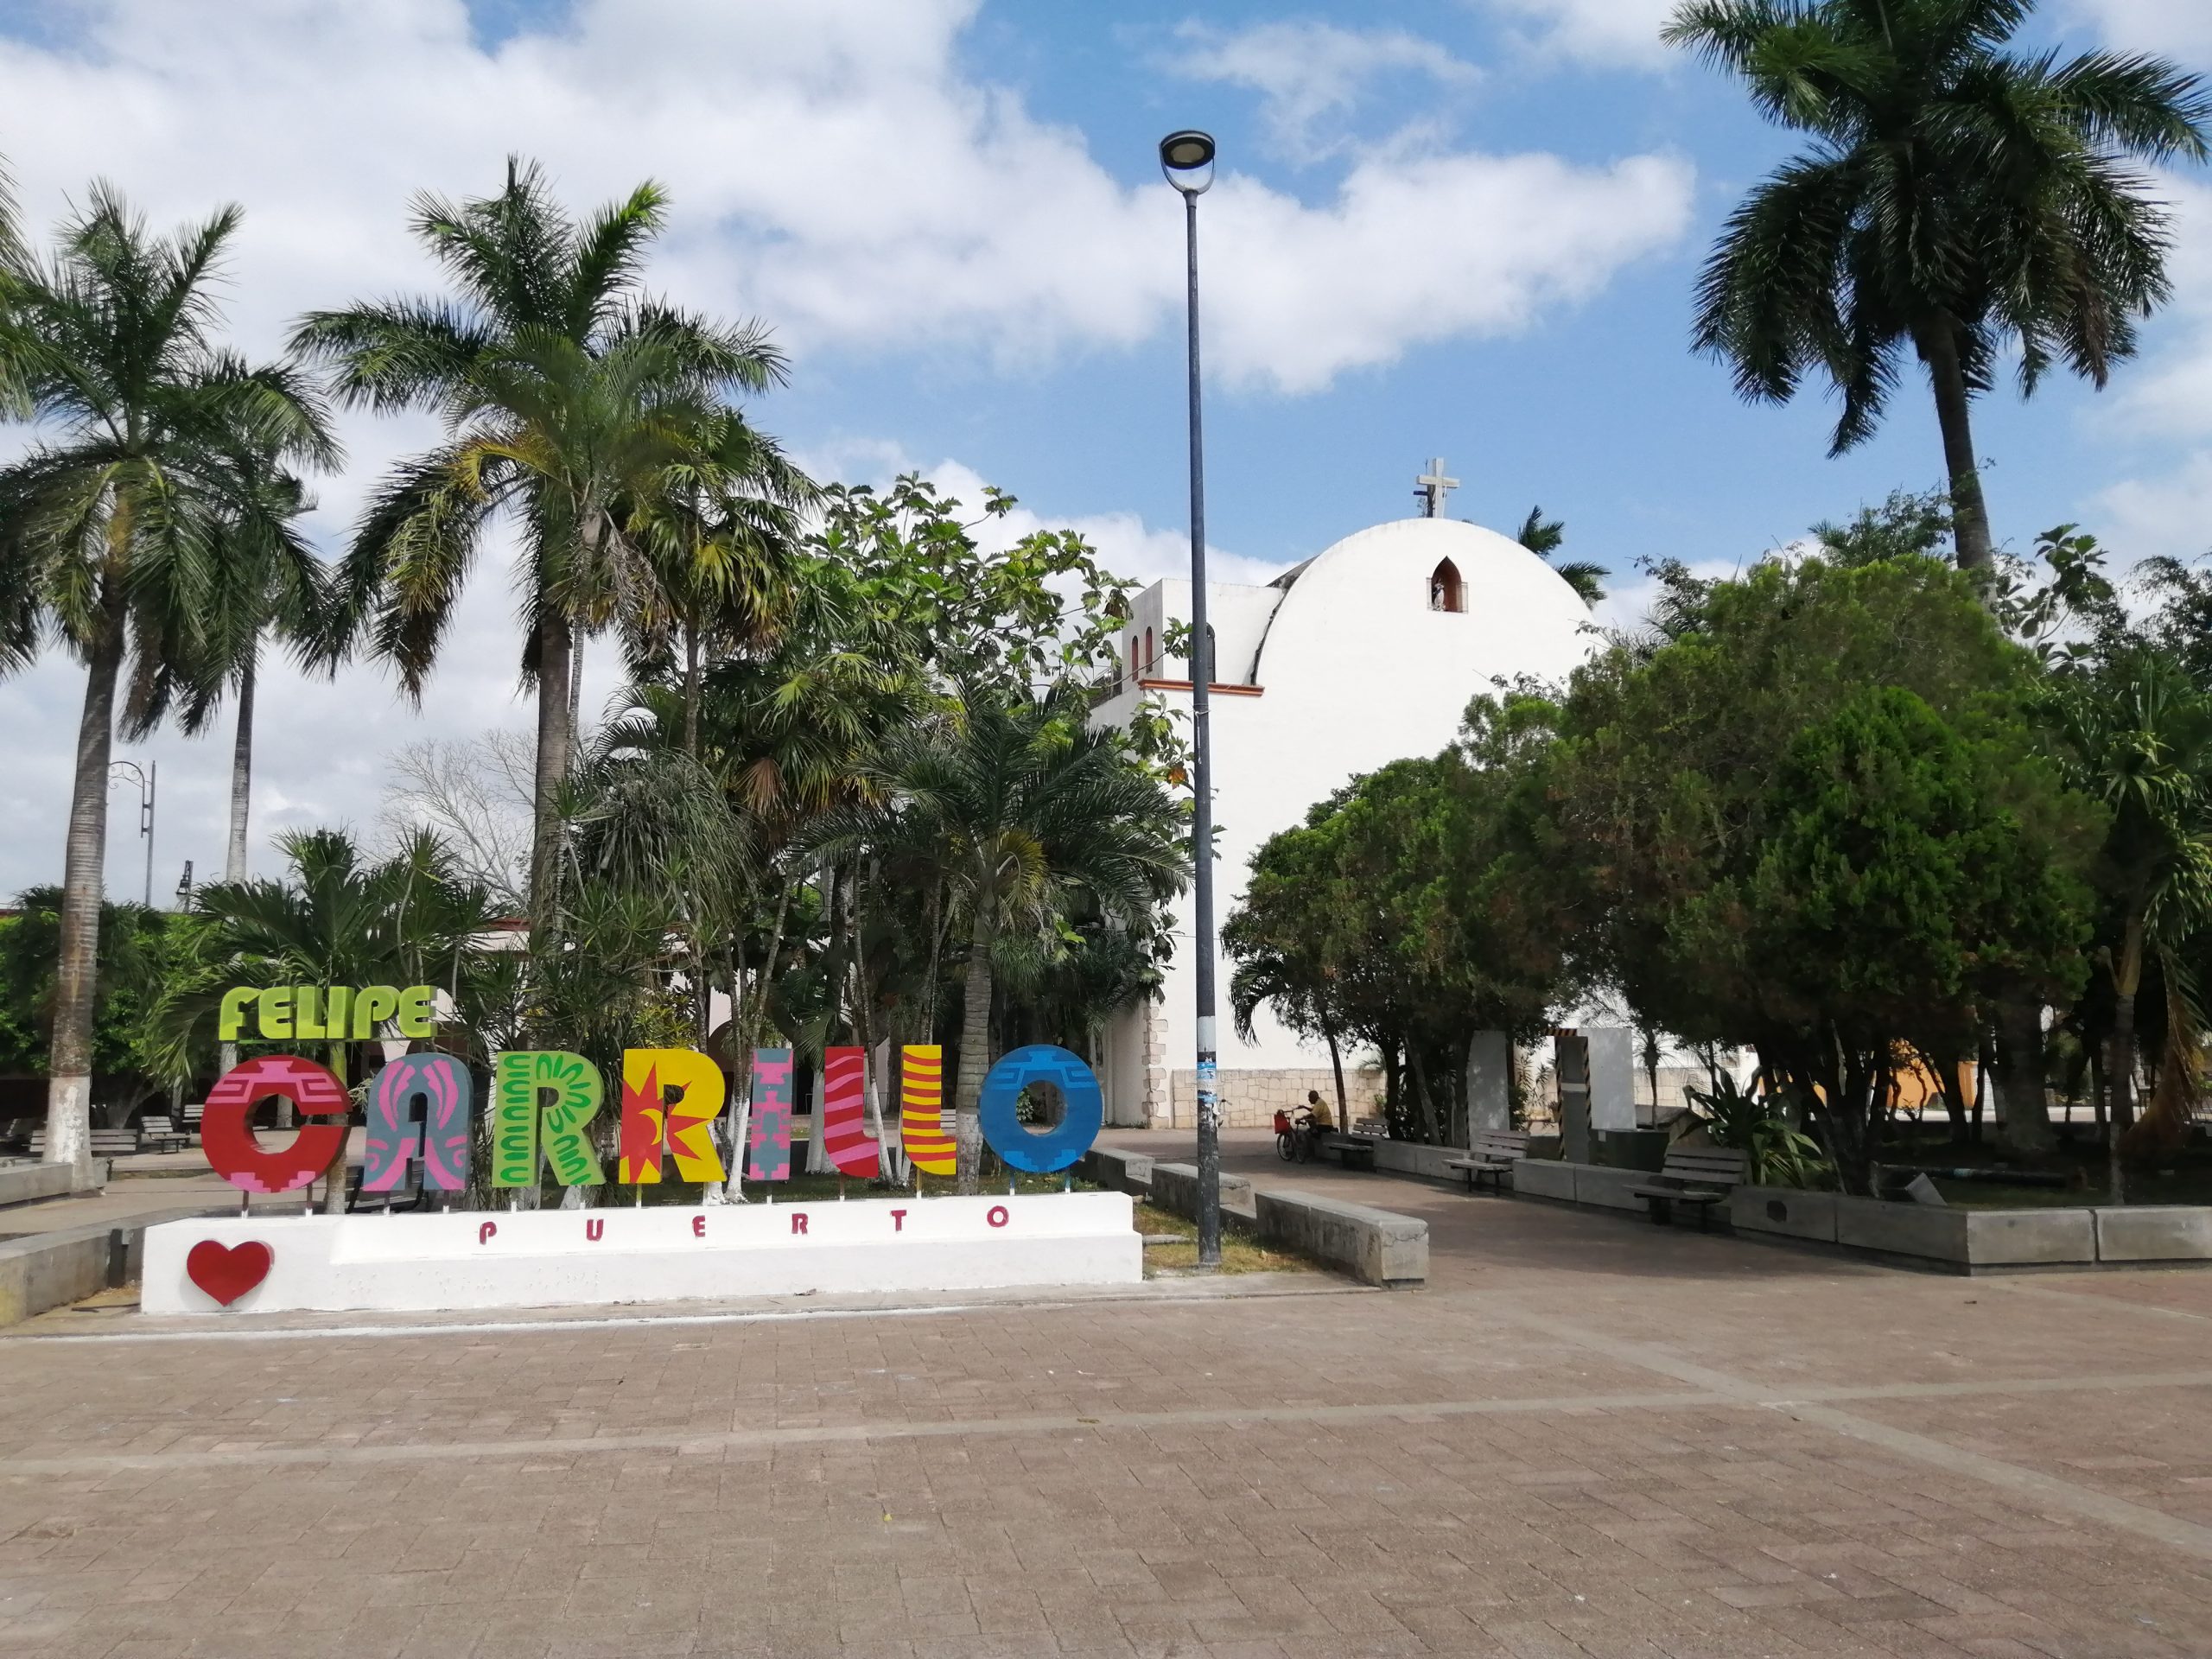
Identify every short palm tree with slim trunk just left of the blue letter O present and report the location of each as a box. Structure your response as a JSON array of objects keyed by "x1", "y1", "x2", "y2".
[{"x1": 844, "y1": 686, "x2": 1190, "y2": 1192}]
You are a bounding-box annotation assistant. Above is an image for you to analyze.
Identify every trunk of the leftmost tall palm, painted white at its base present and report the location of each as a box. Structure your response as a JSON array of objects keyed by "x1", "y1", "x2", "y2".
[{"x1": 47, "y1": 597, "x2": 124, "y2": 1173}]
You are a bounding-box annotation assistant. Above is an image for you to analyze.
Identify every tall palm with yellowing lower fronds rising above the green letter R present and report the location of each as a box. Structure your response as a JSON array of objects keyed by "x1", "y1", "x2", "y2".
[{"x1": 294, "y1": 159, "x2": 783, "y2": 942}]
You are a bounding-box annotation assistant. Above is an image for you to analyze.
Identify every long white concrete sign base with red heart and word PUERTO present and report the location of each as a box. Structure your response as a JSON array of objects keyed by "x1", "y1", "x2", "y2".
[{"x1": 142, "y1": 1192, "x2": 1144, "y2": 1314}]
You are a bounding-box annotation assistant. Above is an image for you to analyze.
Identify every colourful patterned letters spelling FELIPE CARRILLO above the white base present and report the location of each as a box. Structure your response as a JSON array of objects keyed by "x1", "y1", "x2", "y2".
[{"x1": 201, "y1": 1039, "x2": 1106, "y2": 1192}]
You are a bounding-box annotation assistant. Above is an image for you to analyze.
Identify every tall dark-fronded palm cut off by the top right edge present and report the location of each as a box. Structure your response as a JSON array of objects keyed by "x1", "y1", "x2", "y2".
[{"x1": 1666, "y1": 0, "x2": 2212, "y2": 570}]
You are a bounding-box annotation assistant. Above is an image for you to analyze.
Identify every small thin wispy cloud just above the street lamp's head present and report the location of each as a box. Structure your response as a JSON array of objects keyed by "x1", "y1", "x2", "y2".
[{"x1": 1164, "y1": 22, "x2": 1480, "y2": 162}]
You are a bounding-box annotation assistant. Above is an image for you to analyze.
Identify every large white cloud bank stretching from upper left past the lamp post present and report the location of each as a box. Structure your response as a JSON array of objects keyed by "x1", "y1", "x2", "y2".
[{"x1": 0, "y1": 0, "x2": 1688, "y2": 391}]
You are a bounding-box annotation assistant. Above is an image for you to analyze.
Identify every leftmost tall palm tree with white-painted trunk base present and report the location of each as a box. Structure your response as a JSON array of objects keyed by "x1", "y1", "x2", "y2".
[{"x1": 0, "y1": 186, "x2": 336, "y2": 1161}]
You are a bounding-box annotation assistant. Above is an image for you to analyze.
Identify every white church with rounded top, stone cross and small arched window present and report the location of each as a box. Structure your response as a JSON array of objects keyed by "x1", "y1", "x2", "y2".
[{"x1": 1093, "y1": 467, "x2": 1592, "y2": 1128}]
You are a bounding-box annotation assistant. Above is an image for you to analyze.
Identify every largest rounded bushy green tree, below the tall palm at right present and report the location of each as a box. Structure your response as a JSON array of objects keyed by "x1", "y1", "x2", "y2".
[{"x1": 1531, "y1": 556, "x2": 2099, "y2": 1190}]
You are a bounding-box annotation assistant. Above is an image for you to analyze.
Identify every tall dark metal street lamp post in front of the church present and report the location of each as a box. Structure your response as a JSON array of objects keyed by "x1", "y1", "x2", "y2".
[{"x1": 1159, "y1": 130, "x2": 1221, "y2": 1268}]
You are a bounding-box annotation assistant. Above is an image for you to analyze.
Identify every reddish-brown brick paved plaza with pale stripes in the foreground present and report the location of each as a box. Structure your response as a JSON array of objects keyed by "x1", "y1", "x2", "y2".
[{"x1": 0, "y1": 1135, "x2": 2212, "y2": 1659}]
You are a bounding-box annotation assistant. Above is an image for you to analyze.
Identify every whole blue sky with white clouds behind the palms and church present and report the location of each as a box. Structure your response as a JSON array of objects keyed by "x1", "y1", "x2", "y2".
[{"x1": 0, "y1": 0, "x2": 2212, "y2": 892}]
